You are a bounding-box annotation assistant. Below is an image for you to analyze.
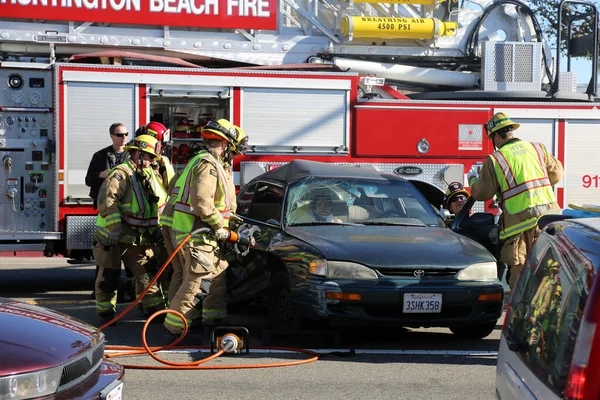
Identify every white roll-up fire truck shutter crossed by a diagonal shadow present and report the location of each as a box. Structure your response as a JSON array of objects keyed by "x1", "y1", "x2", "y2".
[{"x1": 241, "y1": 88, "x2": 349, "y2": 154}]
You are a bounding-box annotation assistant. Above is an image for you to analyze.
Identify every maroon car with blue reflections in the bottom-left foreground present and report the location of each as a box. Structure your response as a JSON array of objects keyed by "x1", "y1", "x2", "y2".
[{"x1": 0, "y1": 298, "x2": 124, "y2": 400}]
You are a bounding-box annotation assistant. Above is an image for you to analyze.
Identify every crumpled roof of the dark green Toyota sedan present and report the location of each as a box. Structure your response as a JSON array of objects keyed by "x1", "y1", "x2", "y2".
[{"x1": 255, "y1": 160, "x2": 404, "y2": 182}]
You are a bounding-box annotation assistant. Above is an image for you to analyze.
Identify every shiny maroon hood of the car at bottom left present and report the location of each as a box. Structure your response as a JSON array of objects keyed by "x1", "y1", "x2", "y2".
[{"x1": 0, "y1": 298, "x2": 104, "y2": 376}]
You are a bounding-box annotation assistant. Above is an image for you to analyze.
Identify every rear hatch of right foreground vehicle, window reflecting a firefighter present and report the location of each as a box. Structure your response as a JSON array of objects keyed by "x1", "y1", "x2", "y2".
[{"x1": 496, "y1": 231, "x2": 589, "y2": 400}]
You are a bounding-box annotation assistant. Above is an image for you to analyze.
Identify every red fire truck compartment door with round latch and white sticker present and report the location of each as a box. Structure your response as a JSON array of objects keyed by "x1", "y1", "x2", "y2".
[{"x1": 356, "y1": 104, "x2": 492, "y2": 157}]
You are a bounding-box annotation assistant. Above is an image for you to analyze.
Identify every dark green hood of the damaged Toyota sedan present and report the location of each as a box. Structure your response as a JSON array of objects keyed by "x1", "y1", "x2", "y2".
[{"x1": 287, "y1": 225, "x2": 494, "y2": 268}]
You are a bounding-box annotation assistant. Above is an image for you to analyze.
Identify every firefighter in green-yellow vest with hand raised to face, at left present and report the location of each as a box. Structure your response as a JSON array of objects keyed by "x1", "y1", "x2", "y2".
[{"x1": 93, "y1": 136, "x2": 164, "y2": 319}]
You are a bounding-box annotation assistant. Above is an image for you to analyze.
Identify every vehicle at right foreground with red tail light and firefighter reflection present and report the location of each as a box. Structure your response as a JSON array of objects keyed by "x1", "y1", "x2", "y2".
[{"x1": 496, "y1": 215, "x2": 600, "y2": 400}]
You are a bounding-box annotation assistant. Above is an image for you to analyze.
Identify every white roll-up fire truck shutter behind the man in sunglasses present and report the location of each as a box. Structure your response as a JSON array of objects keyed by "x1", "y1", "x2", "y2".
[{"x1": 62, "y1": 82, "x2": 137, "y2": 200}]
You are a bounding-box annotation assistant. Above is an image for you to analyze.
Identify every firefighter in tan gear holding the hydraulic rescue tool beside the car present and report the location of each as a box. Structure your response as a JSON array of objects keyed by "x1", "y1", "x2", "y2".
[{"x1": 160, "y1": 119, "x2": 237, "y2": 334}]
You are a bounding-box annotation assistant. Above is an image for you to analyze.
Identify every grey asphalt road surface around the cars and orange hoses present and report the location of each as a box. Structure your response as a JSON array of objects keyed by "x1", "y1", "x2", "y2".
[{"x1": 0, "y1": 257, "x2": 502, "y2": 400}]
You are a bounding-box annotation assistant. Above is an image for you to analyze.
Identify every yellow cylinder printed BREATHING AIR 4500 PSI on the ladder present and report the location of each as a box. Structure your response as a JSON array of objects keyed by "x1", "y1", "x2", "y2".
[{"x1": 340, "y1": 15, "x2": 458, "y2": 40}]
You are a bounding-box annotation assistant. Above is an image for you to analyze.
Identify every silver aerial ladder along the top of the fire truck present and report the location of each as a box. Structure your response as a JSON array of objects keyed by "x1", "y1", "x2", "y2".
[{"x1": 0, "y1": 0, "x2": 535, "y2": 69}]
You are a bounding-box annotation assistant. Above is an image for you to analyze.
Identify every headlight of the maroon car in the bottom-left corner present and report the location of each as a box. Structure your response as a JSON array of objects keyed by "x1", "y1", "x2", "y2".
[{"x1": 0, "y1": 367, "x2": 62, "y2": 400}]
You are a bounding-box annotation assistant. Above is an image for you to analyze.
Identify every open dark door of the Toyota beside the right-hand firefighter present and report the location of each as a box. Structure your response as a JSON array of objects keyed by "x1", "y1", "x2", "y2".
[{"x1": 450, "y1": 198, "x2": 502, "y2": 260}]
